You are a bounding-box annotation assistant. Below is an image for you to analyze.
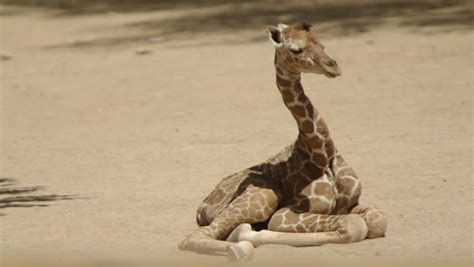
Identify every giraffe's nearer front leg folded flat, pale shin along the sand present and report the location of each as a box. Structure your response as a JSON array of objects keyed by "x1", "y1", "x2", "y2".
[{"x1": 228, "y1": 208, "x2": 367, "y2": 247}]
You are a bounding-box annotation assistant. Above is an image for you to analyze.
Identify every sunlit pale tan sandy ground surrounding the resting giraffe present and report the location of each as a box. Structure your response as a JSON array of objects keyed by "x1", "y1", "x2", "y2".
[{"x1": 0, "y1": 3, "x2": 473, "y2": 266}]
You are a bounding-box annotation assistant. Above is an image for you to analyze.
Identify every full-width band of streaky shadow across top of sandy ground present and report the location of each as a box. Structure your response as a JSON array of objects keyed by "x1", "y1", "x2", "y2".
[{"x1": 0, "y1": 0, "x2": 474, "y2": 48}]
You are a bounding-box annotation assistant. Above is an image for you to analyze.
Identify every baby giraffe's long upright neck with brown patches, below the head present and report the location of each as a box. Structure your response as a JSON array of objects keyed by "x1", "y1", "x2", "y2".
[{"x1": 275, "y1": 57, "x2": 335, "y2": 169}]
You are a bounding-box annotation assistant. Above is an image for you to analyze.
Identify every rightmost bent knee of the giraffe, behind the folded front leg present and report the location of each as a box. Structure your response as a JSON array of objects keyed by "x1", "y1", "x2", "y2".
[{"x1": 350, "y1": 205, "x2": 388, "y2": 238}]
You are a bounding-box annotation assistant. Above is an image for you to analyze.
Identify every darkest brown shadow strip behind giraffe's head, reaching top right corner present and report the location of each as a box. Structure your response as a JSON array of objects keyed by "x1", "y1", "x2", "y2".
[{"x1": 146, "y1": 1, "x2": 473, "y2": 35}]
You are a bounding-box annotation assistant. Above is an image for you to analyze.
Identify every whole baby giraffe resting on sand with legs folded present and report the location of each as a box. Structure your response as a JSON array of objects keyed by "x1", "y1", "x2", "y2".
[{"x1": 179, "y1": 23, "x2": 387, "y2": 260}]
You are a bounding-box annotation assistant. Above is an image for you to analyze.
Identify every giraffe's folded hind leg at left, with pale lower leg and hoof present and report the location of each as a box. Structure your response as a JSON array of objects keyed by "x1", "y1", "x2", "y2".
[{"x1": 178, "y1": 185, "x2": 279, "y2": 261}]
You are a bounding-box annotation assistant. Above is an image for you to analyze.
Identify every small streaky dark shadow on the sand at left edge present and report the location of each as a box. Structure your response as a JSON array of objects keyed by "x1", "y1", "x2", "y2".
[{"x1": 0, "y1": 178, "x2": 77, "y2": 216}]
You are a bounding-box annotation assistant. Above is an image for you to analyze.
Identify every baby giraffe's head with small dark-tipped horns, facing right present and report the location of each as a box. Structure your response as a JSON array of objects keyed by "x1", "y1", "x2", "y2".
[{"x1": 268, "y1": 22, "x2": 341, "y2": 78}]
